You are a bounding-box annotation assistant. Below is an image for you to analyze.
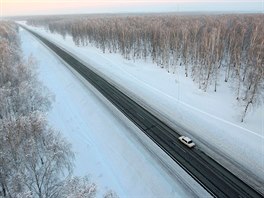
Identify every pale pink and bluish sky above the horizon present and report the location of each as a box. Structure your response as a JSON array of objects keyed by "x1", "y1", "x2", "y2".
[{"x1": 0, "y1": 0, "x2": 264, "y2": 16}]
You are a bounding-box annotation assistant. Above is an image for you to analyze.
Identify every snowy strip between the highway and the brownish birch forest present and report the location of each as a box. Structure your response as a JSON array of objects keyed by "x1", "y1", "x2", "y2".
[{"x1": 19, "y1": 21, "x2": 264, "y2": 192}]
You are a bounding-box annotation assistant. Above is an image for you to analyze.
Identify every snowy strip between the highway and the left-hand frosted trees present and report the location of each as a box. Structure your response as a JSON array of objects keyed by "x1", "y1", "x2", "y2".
[{"x1": 20, "y1": 25, "x2": 210, "y2": 197}]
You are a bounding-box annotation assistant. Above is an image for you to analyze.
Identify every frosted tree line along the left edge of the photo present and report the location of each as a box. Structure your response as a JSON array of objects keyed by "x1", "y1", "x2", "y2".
[{"x1": 0, "y1": 21, "x2": 116, "y2": 198}]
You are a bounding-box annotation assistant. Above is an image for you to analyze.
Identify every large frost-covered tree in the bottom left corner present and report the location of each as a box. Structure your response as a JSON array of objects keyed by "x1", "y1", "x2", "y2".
[{"x1": 0, "y1": 112, "x2": 74, "y2": 197}]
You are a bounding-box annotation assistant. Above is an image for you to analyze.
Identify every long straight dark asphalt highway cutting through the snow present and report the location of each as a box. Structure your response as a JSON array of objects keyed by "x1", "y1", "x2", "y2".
[{"x1": 22, "y1": 26, "x2": 263, "y2": 198}]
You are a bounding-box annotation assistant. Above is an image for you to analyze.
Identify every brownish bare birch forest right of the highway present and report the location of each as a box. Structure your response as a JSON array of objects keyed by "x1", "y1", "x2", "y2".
[{"x1": 28, "y1": 14, "x2": 264, "y2": 122}]
